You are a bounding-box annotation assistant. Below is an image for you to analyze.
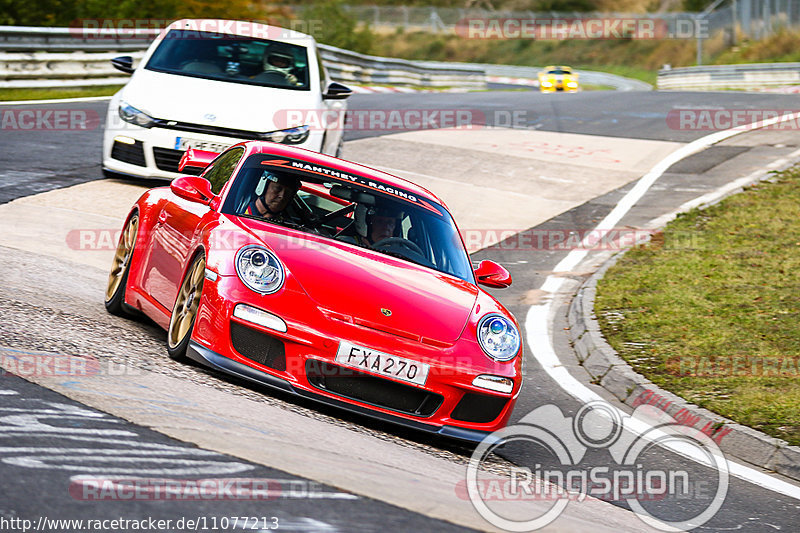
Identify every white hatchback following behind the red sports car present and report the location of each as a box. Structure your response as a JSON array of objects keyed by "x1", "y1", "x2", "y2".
[{"x1": 103, "y1": 19, "x2": 352, "y2": 179}]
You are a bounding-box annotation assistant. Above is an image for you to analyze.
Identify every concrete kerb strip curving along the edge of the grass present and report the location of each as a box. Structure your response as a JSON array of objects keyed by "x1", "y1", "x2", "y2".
[{"x1": 566, "y1": 173, "x2": 800, "y2": 481}]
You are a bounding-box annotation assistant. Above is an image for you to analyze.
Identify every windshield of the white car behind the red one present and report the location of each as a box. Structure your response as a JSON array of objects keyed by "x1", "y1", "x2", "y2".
[{"x1": 145, "y1": 30, "x2": 309, "y2": 91}]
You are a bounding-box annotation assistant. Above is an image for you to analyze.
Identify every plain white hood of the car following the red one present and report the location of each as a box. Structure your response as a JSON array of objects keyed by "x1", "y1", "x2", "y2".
[{"x1": 122, "y1": 68, "x2": 316, "y2": 132}]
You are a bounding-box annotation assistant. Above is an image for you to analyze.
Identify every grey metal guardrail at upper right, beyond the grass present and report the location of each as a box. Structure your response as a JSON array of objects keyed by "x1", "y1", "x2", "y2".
[{"x1": 657, "y1": 63, "x2": 800, "y2": 90}]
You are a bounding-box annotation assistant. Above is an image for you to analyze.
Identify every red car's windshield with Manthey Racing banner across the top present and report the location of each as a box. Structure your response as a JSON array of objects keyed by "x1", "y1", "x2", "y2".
[{"x1": 222, "y1": 155, "x2": 474, "y2": 283}]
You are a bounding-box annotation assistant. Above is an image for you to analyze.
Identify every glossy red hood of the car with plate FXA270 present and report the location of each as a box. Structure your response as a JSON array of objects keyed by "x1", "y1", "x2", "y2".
[{"x1": 239, "y1": 221, "x2": 479, "y2": 344}]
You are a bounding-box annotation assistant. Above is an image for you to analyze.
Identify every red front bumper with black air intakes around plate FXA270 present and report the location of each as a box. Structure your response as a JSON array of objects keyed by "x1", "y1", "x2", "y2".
[{"x1": 190, "y1": 275, "x2": 522, "y2": 441}]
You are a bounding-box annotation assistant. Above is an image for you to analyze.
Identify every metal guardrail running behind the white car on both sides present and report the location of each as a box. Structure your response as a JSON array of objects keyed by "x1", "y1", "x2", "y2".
[{"x1": 0, "y1": 26, "x2": 486, "y2": 89}]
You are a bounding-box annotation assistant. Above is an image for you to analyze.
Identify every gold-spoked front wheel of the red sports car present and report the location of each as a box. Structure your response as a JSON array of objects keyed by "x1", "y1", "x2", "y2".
[{"x1": 167, "y1": 254, "x2": 206, "y2": 362}]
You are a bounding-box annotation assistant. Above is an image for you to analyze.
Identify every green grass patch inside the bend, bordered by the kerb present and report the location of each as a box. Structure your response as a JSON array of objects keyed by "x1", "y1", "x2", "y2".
[{"x1": 595, "y1": 167, "x2": 800, "y2": 445}]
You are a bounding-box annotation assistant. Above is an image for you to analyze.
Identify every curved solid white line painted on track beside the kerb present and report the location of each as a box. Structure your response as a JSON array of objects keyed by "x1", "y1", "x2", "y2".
[{"x1": 525, "y1": 113, "x2": 800, "y2": 500}]
